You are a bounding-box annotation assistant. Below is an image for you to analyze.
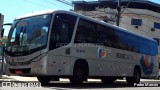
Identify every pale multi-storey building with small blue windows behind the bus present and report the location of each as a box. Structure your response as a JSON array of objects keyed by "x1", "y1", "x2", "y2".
[{"x1": 73, "y1": 0, "x2": 160, "y2": 52}]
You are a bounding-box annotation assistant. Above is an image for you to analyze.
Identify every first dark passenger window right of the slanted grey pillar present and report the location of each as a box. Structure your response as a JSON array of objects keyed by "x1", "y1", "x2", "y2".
[{"x1": 74, "y1": 19, "x2": 97, "y2": 43}]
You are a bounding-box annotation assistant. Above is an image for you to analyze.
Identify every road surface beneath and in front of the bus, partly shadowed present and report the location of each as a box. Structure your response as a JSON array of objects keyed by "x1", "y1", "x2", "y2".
[{"x1": 0, "y1": 76, "x2": 160, "y2": 90}]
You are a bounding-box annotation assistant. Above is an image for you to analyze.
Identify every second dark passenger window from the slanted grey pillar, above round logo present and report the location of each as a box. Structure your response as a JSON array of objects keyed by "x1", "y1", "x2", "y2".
[{"x1": 97, "y1": 25, "x2": 114, "y2": 47}]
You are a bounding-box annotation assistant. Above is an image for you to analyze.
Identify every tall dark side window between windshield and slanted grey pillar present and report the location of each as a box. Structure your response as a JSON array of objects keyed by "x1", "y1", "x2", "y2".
[{"x1": 49, "y1": 14, "x2": 77, "y2": 50}]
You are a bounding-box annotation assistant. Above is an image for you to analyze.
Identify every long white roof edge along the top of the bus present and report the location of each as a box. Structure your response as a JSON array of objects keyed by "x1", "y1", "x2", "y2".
[{"x1": 16, "y1": 10, "x2": 156, "y2": 42}]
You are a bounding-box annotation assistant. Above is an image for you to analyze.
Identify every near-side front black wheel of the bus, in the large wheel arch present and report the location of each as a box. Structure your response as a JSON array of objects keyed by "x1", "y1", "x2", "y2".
[{"x1": 69, "y1": 63, "x2": 88, "y2": 84}]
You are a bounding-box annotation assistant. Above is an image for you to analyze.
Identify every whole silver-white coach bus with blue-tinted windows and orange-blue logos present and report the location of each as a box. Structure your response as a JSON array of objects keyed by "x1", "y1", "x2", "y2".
[{"x1": 5, "y1": 10, "x2": 158, "y2": 83}]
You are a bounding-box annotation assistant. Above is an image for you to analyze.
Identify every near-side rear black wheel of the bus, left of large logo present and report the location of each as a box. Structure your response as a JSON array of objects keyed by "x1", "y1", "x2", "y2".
[{"x1": 126, "y1": 68, "x2": 141, "y2": 84}]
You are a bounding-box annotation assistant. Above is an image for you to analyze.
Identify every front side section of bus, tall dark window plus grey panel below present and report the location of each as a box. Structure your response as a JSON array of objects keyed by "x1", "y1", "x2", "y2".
[{"x1": 49, "y1": 13, "x2": 77, "y2": 75}]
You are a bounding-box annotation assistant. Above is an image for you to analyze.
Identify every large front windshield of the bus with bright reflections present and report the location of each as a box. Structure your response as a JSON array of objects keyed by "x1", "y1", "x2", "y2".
[{"x1": 6, "y1": 15, "x2": 52, "y2": 53}]
